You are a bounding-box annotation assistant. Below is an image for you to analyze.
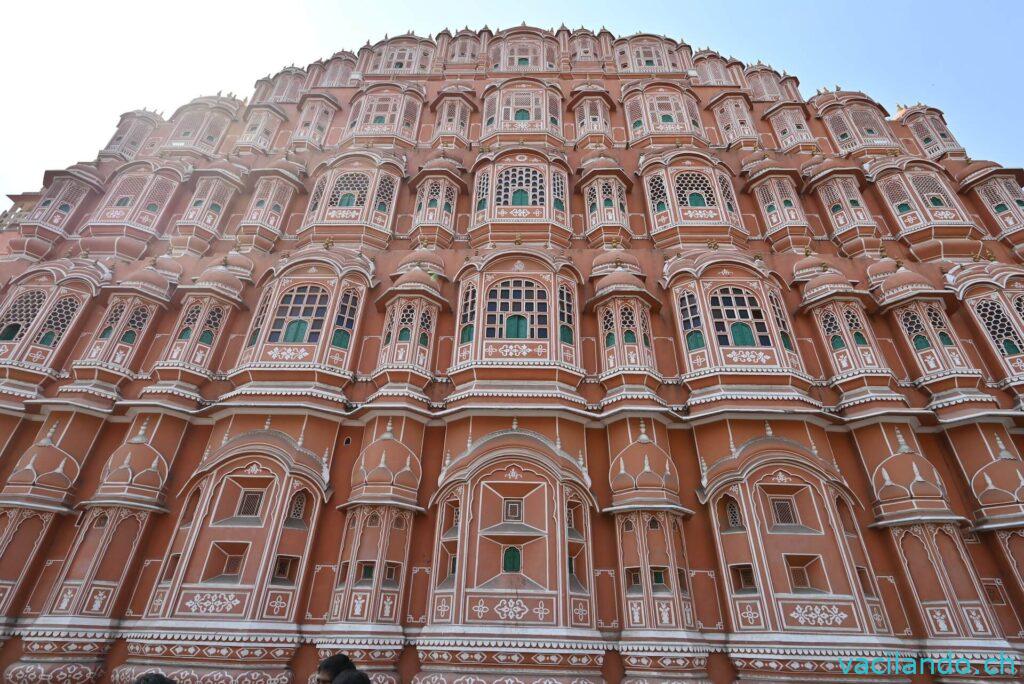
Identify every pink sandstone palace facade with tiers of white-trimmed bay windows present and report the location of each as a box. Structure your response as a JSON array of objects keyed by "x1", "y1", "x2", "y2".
[{"x1": 0, "y1": 22, "x2": 1024, "y2": 684}]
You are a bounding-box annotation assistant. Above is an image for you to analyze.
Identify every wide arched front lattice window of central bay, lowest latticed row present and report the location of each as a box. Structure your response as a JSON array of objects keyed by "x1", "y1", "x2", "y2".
[{"x1": 484, "y1": 279, "x2": 549, "y2": 340}]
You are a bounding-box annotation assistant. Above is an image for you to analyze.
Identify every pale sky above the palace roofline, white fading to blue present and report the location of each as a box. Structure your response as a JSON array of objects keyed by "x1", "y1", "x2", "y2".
[{"x1": 0, "y1": 0, "x2": 1024, "y2": 209}]
